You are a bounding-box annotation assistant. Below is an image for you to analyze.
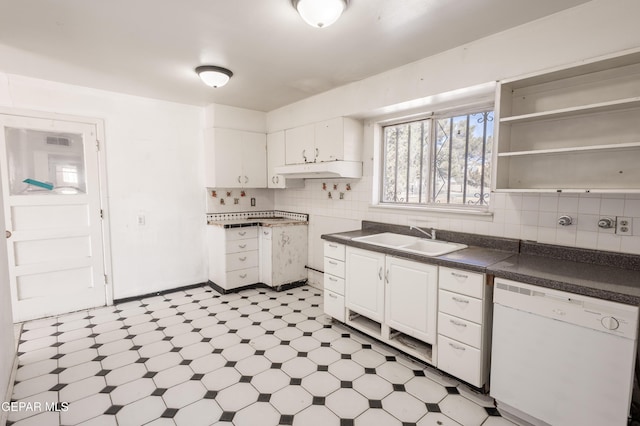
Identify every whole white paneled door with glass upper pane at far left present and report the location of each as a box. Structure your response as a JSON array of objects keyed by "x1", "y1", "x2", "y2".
[{"x1": 0, "y1": 114, "x2": 107, "y2": 322}]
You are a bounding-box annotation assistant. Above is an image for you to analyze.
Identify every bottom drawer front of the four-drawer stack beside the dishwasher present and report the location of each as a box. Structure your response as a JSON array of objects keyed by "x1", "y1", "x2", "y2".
[{"x1": 438, "y1": 335, "x2": 484, "y2": 387}]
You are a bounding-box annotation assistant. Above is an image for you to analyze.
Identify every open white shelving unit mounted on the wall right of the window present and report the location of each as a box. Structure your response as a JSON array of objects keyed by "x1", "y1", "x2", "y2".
[{"x1": 493, "y1": 49, "x2": 640, "y2": 193}]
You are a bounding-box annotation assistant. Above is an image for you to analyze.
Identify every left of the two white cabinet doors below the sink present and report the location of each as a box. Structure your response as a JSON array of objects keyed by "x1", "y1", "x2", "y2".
[{"x1": 345, "y1": 247, "x2": 385, "y2": 322}]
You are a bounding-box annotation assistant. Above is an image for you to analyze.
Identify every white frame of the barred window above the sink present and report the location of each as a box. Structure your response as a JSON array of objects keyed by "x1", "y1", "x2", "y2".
[{"x1": 372, "y1": 99, "x2": 497, "y2": 216}]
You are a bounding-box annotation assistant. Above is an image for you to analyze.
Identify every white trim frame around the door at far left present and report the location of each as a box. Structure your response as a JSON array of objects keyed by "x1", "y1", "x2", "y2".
[{"x1": 0, "y1": 106, "x2": 114, "y2": 306}]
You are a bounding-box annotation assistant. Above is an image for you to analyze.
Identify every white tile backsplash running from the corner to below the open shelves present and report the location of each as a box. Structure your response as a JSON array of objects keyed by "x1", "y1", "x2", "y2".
[{"x1": 274, "y1": 176, "x2": 640, "y2": 255}]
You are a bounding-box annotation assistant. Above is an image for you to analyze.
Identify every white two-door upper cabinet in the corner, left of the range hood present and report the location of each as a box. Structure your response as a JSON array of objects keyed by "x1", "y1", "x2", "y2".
[{"x1": 204, "y1": 128, "x2": 267, "y2": 188}]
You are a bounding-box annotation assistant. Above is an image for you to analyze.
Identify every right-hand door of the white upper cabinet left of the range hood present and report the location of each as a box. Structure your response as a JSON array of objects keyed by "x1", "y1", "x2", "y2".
[{"x1": 241, "y1": 132, "x2": 267, "y2": 188}]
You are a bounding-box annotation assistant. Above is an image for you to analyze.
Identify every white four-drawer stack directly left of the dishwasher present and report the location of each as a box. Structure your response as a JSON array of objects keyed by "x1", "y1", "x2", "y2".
[{"x1": 437, "y1": 267, "x2": 492, "y2": 387}]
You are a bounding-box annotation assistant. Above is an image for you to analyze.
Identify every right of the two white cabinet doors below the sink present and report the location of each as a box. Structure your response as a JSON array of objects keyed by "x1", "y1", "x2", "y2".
[{"x1": 385, "y1": 257, "x2": 438, "y2": 344}]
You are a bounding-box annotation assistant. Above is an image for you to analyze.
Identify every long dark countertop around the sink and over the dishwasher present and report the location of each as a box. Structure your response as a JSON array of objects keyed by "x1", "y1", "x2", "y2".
[{"x1": 322, "y1": 222, "x2": 640, "y2": 306}]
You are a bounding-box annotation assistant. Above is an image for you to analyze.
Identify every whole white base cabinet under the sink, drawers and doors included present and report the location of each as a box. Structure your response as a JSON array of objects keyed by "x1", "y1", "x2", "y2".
[{"x1": 324, "y1": 242, "x2": 493, "y2": 388}]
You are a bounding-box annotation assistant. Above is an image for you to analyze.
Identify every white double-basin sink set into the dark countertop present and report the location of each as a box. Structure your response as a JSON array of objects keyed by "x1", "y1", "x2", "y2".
[{"x1": 353, "y1": 232, "x2": 467, "y2": 256}]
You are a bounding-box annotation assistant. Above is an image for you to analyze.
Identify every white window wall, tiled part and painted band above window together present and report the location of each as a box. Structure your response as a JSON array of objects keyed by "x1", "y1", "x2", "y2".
[{"x1": 267, "y1": 0, "x2": 640, "y2": 282}]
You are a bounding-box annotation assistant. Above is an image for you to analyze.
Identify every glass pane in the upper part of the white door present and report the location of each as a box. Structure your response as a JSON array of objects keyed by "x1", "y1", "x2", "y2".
[{"x1": 5, "y1": 127, "x2": 87, "y2": 195}]
